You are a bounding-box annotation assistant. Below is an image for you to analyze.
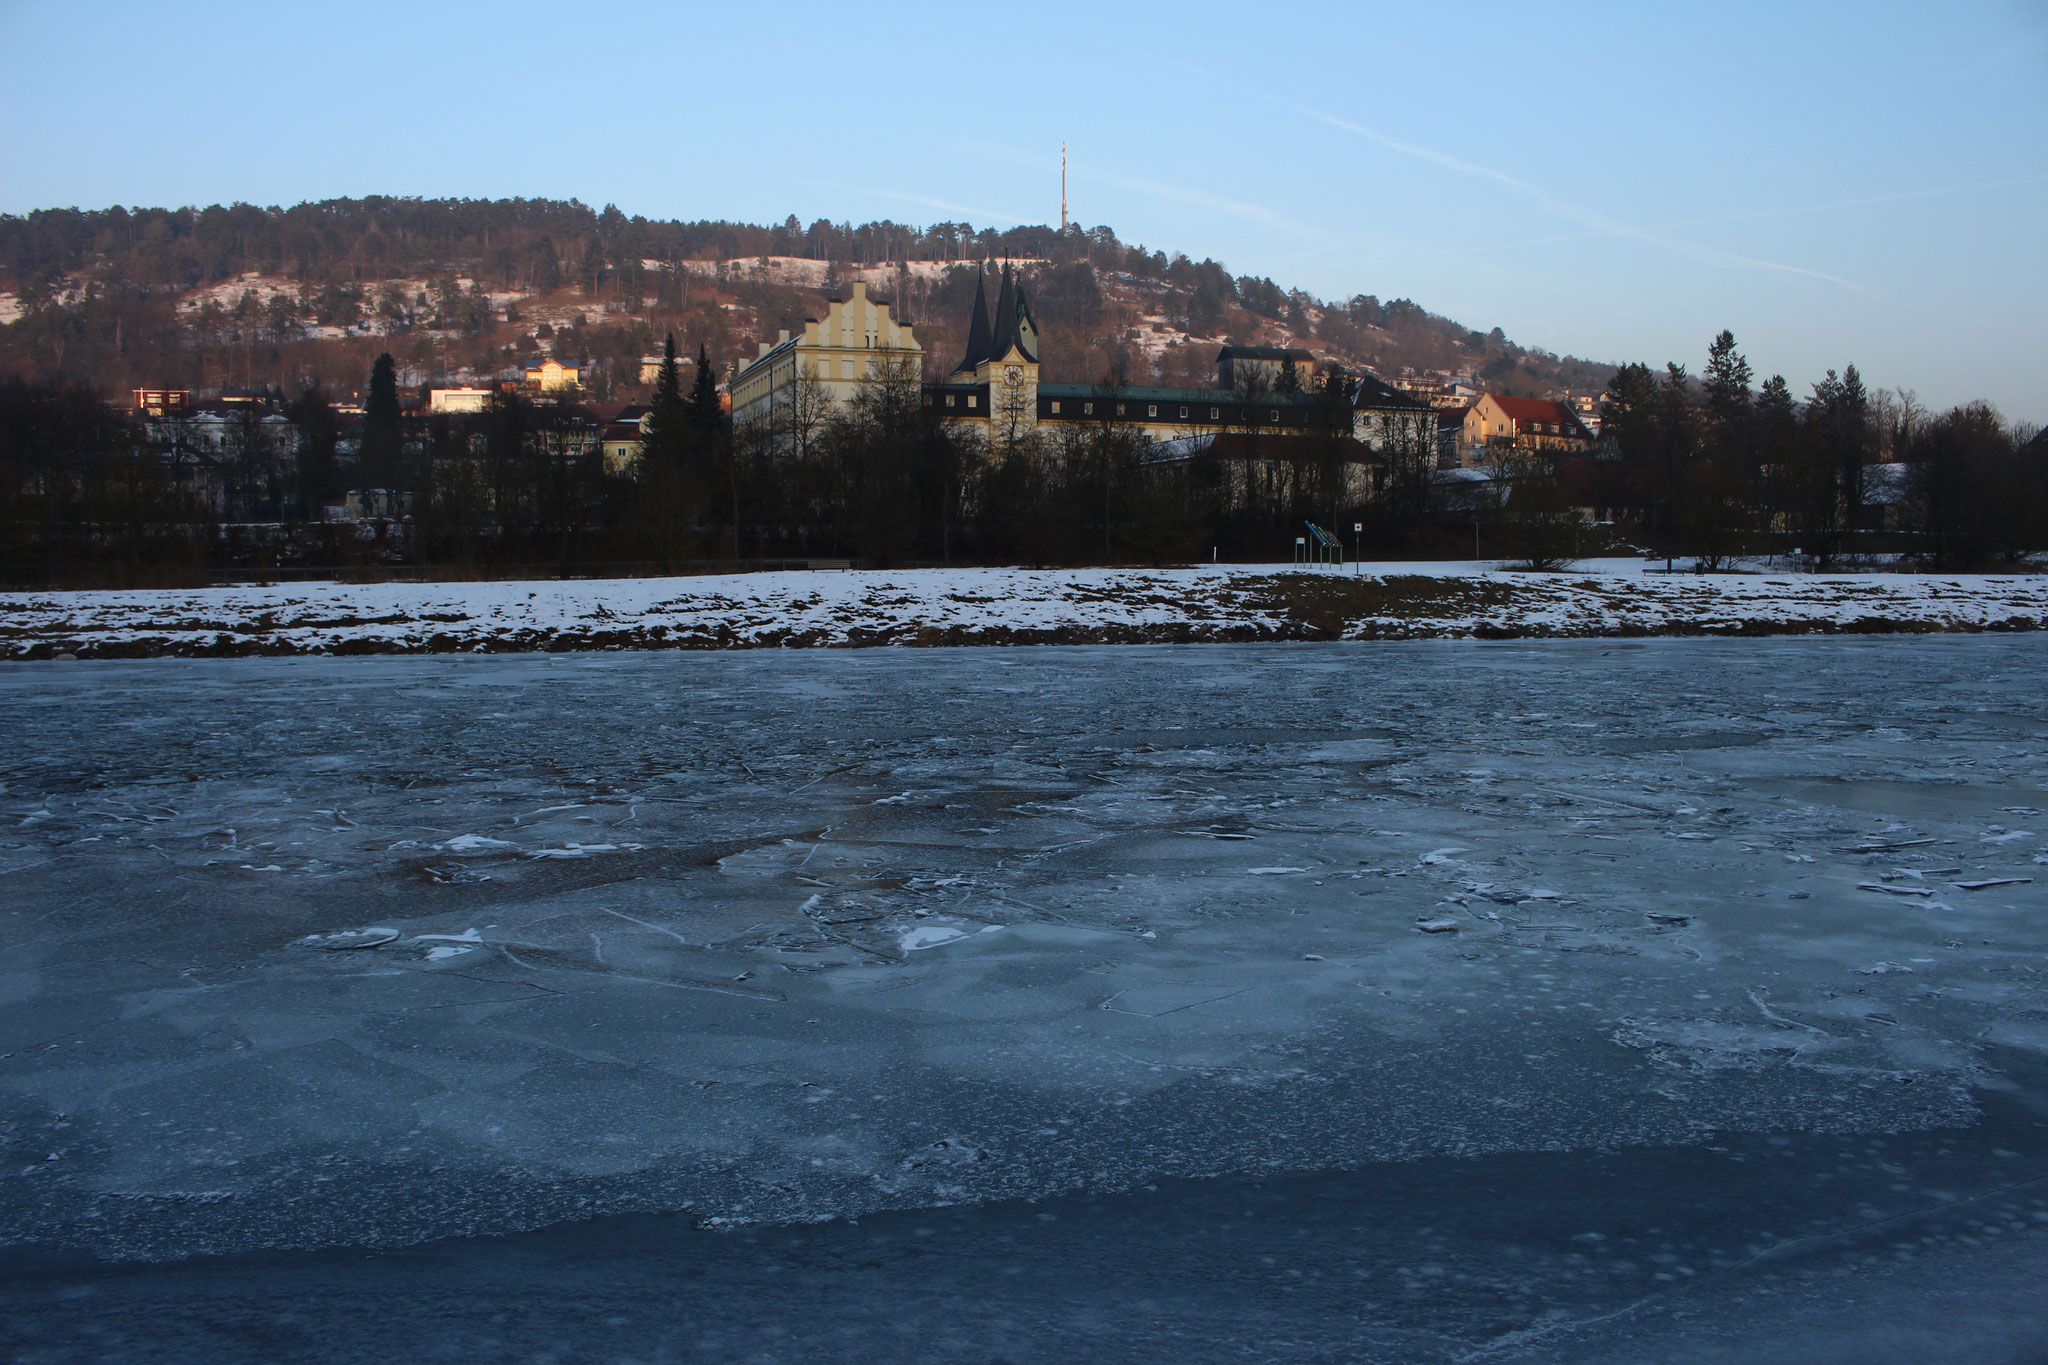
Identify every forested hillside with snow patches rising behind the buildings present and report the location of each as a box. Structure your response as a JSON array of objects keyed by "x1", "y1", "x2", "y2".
[{"x1": 0, "y1": 196, "x2": 1614, "y2": 397}]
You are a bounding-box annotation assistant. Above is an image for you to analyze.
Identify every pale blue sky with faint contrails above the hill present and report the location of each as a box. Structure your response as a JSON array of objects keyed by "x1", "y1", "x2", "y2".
[{"x1": 0, "y1": 0, "x2": 2048, "y2": 422}]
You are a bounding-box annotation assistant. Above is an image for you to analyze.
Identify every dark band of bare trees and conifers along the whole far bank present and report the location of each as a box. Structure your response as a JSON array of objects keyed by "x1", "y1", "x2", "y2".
[{"x1": 0, "y1": 332, "x2": 2048, "y2": 583}]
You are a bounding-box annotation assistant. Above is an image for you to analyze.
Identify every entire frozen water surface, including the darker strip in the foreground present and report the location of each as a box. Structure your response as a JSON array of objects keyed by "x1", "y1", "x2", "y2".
[{"x1": 0, "y1": 636, "x2": 2048, "y2": 1365}]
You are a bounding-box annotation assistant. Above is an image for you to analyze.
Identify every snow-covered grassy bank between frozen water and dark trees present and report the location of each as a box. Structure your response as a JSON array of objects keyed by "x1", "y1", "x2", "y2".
[{"x1": 0, "y1": 561, "x2": 2048, "y2": 659}]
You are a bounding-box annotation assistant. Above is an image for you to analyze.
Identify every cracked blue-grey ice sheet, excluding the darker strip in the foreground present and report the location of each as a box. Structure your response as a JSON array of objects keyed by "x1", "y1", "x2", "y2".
[{"x1": 0, "y1": 639, "x2": 2048, "y2": 1257}]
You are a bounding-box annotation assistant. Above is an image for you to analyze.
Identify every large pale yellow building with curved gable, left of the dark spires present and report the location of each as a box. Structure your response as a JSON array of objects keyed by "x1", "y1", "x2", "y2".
[{"x1": 731, "y1": 284, "x2": 924, "y2": 444}]
